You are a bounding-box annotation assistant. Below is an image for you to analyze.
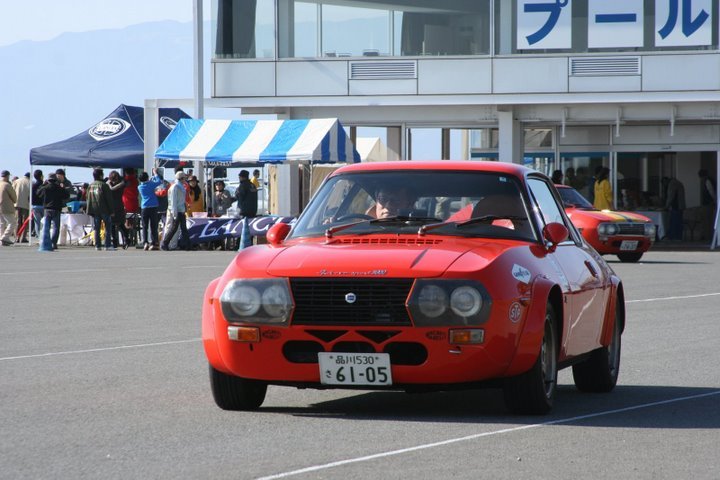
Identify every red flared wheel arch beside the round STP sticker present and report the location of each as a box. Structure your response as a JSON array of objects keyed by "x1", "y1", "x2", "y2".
[{"x1": 505, "y1": 277, "x2": 555, "y2": 377}]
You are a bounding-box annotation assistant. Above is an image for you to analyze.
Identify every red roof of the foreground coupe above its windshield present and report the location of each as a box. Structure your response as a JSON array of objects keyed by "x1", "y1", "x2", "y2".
[{"x1": 333, "y1": 160, "x2": 535, "y2": 178}]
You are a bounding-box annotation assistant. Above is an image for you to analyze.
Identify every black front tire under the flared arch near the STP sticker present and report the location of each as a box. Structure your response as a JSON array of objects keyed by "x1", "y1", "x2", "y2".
[{"x1": 503, "y1": 304, "x2": 558, "y2": 415}]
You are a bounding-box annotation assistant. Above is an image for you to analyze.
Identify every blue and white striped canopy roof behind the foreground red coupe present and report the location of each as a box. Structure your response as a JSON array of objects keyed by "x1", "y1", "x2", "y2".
[{"x1": 155, "y1": 118, "x2": 360, "y2": 164}]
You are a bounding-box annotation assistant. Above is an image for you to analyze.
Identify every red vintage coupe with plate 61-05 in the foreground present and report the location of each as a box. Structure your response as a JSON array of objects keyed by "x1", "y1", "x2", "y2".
[{"x1": 202, "y1": 161, "x2": 625, "y2": 414}]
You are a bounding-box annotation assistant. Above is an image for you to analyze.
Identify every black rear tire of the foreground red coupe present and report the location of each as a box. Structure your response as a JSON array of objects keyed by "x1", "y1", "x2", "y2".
[{"x1": 573, "y1": 308, "x2": 622, "y2": 393}]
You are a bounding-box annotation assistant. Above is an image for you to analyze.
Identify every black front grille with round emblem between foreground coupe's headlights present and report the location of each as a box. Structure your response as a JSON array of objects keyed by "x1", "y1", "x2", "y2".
[{"x1": 290, "y1": 278, "x2": 413, "y2": 326}]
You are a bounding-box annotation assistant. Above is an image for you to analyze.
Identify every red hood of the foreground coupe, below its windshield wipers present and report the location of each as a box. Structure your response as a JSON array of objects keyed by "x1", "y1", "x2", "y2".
[{"x1": 267, "y1": 238, "x2": 517, "y2": 277}]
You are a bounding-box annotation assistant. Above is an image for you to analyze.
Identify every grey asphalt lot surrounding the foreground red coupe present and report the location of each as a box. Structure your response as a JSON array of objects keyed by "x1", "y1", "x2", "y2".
[{"x1": 0, "y1": 246, "x2": 720, "y2": 480}]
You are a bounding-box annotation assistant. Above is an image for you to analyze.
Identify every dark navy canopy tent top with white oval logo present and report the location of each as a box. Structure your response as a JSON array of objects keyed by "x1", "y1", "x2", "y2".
[{"x1": 30, "y1": 105, "x2": 190, "y2": 169}]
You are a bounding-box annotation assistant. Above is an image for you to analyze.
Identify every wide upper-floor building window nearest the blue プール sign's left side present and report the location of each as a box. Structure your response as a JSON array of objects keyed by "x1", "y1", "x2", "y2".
[{"x1": 278, "y1": 0, "x2": 490, "y2": 58}]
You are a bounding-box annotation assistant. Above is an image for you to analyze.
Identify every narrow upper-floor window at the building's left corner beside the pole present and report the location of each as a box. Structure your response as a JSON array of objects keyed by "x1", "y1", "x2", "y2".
[{"x1": 213, "y1": 0, "x2": 275, "y2": 59}]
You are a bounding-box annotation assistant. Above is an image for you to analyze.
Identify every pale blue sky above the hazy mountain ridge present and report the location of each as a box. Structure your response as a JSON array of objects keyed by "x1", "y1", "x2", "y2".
[{"x1": 0, "y1": 0, "x2": 202, "y2": 46}]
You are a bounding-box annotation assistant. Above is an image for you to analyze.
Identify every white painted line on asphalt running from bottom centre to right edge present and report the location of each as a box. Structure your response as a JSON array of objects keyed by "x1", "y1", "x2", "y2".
[{"x1": 257, "y1": 390, "x2": 720, "y2": 480}]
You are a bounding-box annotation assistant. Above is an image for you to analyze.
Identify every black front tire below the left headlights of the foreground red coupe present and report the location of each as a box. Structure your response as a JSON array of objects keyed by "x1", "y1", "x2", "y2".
[{"x1": 210, "y1": 365, "x2": 267, "y2": 410}]
